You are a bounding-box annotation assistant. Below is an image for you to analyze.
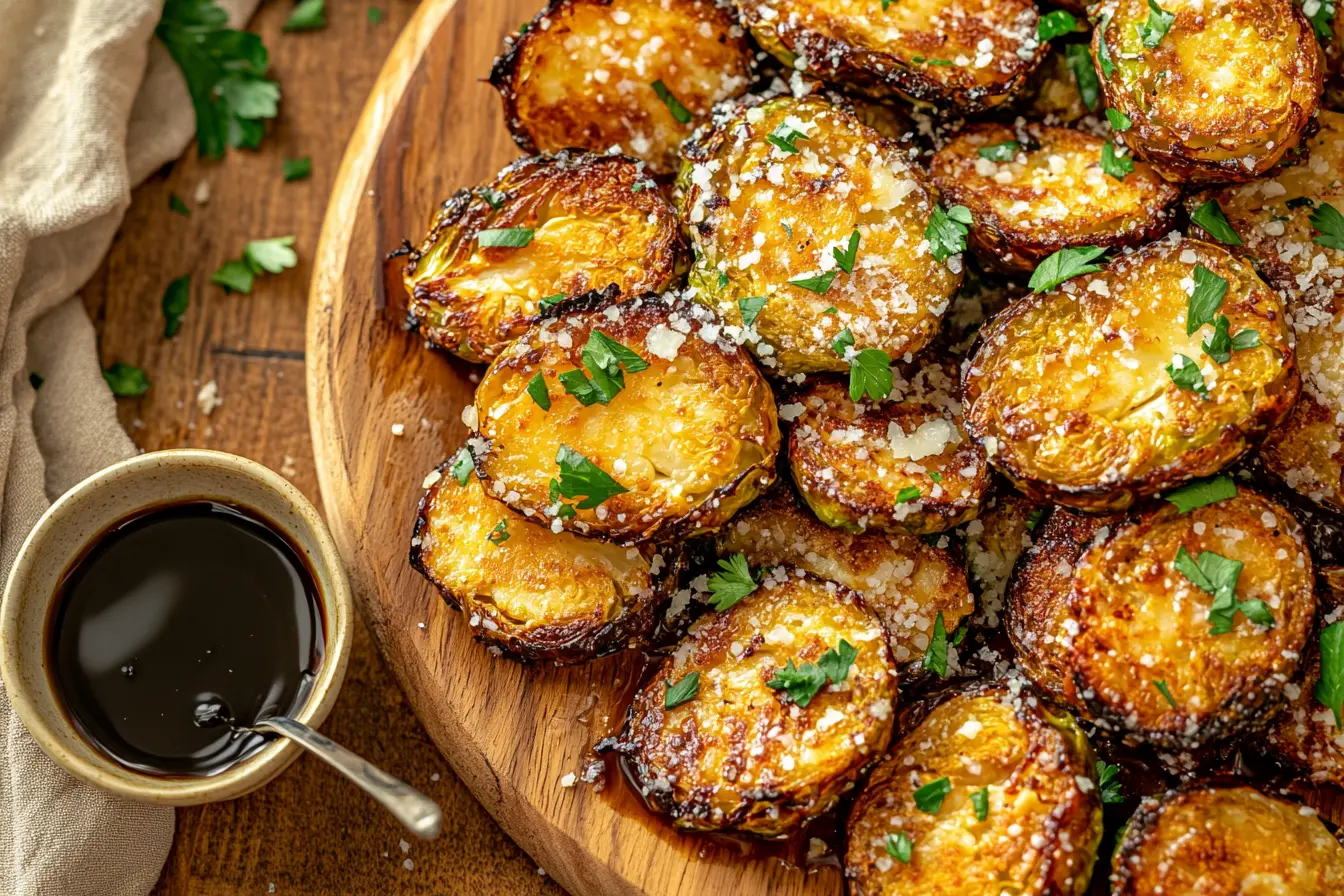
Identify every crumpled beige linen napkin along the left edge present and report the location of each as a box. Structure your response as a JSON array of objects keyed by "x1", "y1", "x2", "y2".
[{"x1": 0, "y1": 0, "x2": 257, "y2": 896}]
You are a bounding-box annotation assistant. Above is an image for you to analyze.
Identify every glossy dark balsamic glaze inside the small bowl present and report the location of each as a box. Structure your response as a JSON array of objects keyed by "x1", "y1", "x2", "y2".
[{"x1": 47, "y1": 501, "x2": 324, "y2": 776}]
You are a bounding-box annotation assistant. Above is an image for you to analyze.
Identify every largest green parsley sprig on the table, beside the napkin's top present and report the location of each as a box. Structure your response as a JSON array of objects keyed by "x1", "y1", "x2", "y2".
[{"x1": 155, "y1": 0, "x2": 280, "y2": 159}]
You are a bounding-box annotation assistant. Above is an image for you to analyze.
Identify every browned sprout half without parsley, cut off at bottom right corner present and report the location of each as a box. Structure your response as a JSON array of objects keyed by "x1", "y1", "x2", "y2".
[{"x1": 1110, "y1": 786, "x2": 1344, "y2": 896}]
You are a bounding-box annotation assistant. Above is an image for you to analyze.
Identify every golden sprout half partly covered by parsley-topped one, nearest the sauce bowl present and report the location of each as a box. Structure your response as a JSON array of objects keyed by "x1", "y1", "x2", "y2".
[{"x1": 411, "y1": 461, "x2": 683, "y2": 662}]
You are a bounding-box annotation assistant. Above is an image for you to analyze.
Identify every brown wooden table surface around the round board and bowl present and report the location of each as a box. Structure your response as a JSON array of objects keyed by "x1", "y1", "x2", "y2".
[{"x1": 83, "y1": 0, "x2": 563, "y2": 896}]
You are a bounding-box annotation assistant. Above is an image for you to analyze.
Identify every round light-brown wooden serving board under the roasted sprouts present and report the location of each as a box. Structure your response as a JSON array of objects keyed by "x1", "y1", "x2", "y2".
[{"x1": 308, "y1": 0, "x2": 841, "y2": 896}]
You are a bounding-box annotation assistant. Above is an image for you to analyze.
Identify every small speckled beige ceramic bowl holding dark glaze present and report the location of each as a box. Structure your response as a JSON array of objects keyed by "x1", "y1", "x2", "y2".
[{"x1": 0, "y1": 450, "x2": 353, "y2": 806}]
